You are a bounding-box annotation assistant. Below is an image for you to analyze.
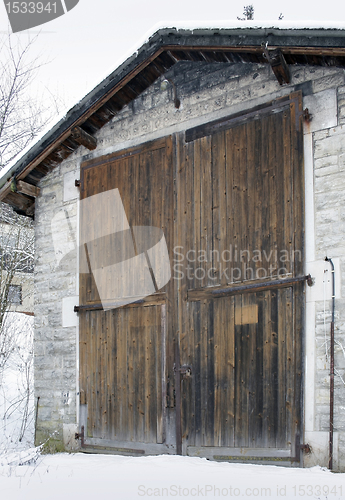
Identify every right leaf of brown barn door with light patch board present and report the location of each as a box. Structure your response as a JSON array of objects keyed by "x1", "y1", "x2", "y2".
[{"x1": 176, "y1": 94, "x2": 304, "y2": 463}]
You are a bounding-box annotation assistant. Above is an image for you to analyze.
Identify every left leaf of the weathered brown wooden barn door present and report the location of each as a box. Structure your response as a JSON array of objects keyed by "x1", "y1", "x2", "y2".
[{"x1": 79, "y1": 138, "x2": 173, "y2": 455}]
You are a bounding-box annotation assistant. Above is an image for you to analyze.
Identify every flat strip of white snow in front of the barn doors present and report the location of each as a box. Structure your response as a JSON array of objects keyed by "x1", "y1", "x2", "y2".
[{"x1": 0, "y1": 449, "x2": 345, "y2": 500}]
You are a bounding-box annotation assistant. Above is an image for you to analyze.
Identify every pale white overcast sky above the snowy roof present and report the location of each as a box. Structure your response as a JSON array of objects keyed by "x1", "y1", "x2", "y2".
[{"x1": 0, "y1": 0, "x2": 345, "y2": 112}]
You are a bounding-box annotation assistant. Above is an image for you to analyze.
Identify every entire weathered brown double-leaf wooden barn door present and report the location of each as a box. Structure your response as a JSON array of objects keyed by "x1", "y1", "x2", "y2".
[{"x1": 79, "y1": 93, "x2": 304, "y2": 463}]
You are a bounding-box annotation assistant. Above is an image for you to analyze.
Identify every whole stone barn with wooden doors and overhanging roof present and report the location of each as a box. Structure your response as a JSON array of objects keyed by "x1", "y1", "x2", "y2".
[{"x1": 1, "y1": 28, "x2": 345, "y2": 470}]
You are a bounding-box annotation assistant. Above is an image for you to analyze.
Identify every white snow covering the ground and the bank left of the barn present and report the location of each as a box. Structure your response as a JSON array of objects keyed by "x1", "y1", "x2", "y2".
[{"x1": 0, "y1": 315, "x2": 345, "y2": 500}]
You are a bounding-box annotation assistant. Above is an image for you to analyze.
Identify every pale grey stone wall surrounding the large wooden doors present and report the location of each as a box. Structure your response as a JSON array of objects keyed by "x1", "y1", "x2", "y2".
[{"x1": 35, "y1": 58, "x2": 345, "y2": 470}]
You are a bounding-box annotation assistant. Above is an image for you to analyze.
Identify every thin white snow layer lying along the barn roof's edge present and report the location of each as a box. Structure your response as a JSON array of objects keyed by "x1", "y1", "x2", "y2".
[{"x1": 0, "y1": 20, "x2": 345, "y2": 187}]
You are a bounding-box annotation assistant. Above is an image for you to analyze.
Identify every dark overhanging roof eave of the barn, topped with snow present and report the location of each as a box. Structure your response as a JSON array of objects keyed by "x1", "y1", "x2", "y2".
[{"x1": 0, "y1": 25, "x2": 345, "y2": 215}]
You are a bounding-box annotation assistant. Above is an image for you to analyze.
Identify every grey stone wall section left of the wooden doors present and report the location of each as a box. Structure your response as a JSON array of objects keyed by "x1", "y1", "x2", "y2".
[{"x1": 34, "y1": 160, "x2": 78, "y2": 450}]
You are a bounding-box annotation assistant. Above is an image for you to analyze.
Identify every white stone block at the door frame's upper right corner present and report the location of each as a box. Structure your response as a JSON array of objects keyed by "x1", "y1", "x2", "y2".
[{"x1": 303, "y1": 89, "x2": 338, "y2": 133}]
